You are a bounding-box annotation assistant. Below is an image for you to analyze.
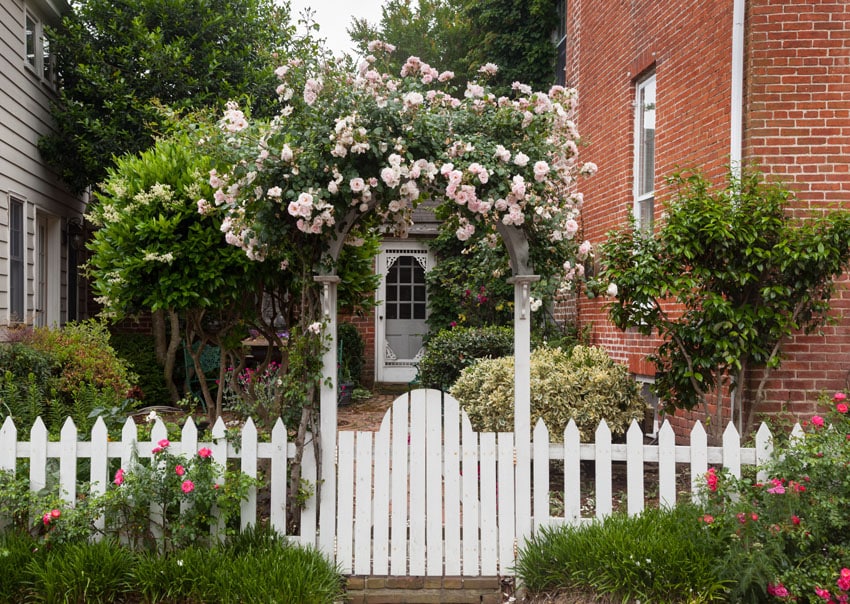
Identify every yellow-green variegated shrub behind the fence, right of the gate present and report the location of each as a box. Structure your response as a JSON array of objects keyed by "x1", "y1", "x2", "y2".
[{"x1": 450, "y1": 346, "x2": 646, "y2": 441}]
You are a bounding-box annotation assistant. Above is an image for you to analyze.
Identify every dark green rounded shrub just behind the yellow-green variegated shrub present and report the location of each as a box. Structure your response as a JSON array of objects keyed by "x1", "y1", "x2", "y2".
[{"x1": 419, "y1": 327, "x2": 514, "y2": 389}]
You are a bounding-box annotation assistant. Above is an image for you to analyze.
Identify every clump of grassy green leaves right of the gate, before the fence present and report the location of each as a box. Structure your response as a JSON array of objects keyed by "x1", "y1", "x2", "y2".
[{"x1": 516, "y1": 505, "x2": 728, "y2": 604}]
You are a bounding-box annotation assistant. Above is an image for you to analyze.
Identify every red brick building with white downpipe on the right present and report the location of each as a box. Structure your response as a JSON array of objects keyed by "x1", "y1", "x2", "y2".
[{"x1": 566, "y1": 0, "x2": 850, "y2": 434}]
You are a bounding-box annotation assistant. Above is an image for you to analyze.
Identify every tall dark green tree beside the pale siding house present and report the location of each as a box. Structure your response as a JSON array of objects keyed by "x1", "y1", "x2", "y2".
[{"x1": 39, "y1": 0, "x2": 293, "y2": 191}]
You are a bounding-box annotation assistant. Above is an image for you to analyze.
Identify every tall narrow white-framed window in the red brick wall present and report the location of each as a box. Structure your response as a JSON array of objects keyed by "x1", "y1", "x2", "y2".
[{"x1": 634, "y1": 73, "x2": 655, "y2": 229}]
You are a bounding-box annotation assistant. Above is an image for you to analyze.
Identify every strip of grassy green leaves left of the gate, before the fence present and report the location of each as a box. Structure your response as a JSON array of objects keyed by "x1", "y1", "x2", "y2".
[{"x1": 0, "y1": 527, "x2": 343, "y2": 604}]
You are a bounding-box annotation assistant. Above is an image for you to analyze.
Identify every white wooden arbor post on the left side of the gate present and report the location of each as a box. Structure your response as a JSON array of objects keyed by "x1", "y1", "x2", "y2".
[{"x1": 314, "y1": 275, "x2": 339, "y2": 556}]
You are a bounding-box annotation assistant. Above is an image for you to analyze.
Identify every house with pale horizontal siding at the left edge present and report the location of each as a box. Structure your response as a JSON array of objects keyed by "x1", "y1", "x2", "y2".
[{"x1": 0, "y1": 0, "x2": 85, "y2": 339}]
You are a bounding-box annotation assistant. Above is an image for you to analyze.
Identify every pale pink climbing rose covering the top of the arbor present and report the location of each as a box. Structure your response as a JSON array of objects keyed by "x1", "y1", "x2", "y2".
[{"x1": 198, "y1": 42, "x2": 596, "y2": 277}]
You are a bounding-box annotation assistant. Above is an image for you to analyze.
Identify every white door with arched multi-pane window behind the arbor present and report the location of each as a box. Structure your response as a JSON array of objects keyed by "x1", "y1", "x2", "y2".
[{"x1": 375, "y1": 241, "x2": 433, "y2": 383}]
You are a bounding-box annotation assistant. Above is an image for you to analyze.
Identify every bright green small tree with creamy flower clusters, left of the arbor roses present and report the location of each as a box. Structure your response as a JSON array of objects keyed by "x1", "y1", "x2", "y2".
[{"x1": 88, "y1": 134, "x2": 263, "y2": 317}]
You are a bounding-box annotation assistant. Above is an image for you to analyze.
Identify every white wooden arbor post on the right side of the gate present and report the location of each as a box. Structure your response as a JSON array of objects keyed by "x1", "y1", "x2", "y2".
[{"x1": 508, "y1": 275, "x2": 548, "y2": 545}]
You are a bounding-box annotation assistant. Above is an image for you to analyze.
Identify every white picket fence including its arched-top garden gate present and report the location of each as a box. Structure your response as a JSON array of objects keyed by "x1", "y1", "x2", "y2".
[{"x1": 0, "y1": 390, "x2": 772, "y2": 576}]
